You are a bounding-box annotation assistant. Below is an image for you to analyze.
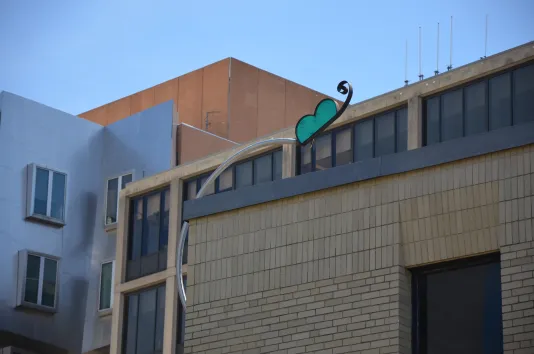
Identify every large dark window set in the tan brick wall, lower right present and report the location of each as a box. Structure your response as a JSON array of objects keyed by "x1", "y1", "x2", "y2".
[{"x1": 412, "y1": 255, "x2": 503, "y2": 354}]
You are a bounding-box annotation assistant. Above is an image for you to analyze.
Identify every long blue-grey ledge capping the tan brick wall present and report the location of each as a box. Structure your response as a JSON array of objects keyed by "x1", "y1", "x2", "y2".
[{"x1": 183, "y1": 122, "x2": 534, "y2": 220}]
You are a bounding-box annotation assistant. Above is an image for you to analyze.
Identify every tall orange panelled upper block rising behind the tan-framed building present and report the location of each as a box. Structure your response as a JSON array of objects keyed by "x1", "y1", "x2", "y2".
[{"x1": 80, "y1": 58, "x2": 340, "y2": 143}]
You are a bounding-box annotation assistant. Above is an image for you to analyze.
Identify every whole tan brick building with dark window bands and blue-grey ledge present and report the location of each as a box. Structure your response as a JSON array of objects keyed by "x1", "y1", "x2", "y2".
[{"x1": 110, "y1": 42, "x2": 534, "y2": 354}]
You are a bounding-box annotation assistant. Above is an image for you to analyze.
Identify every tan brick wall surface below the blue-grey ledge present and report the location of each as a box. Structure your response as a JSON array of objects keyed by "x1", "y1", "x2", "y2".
[{"x1": 186, "y1": 146, "x2": 534, "y2": 353}]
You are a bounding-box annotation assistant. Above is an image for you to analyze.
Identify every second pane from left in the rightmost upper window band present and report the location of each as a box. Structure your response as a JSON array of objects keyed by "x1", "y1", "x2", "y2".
[{"x1": 441, "y1": 89, "x2": 463, "y2": 141}]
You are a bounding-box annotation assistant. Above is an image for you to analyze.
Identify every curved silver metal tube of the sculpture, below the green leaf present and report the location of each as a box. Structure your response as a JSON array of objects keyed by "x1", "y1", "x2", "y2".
[{"x1": 176, "y1": 138, "x2": 297, "y2": 310}]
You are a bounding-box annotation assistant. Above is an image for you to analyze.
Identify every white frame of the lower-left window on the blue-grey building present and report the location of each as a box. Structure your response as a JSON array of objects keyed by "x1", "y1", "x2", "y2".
[{"x1": 16, "y1": 250, "x2": 60, "y2": 312}]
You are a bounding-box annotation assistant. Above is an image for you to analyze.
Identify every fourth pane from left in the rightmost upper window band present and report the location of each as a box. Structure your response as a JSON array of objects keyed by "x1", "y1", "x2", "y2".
[{"x1": 489, "y1": 73, "x2": 512, "y2": 129}]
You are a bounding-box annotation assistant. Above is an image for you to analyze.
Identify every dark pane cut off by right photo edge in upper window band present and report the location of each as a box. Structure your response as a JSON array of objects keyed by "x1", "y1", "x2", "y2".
[{"x1": 514, "y1": 64, "x2": 534, "y2": 124}]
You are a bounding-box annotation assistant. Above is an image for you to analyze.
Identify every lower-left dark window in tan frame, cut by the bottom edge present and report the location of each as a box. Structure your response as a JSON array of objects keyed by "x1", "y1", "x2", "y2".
[{"x1": 123, "y1": 285, "x2": 165, "y2": 354}]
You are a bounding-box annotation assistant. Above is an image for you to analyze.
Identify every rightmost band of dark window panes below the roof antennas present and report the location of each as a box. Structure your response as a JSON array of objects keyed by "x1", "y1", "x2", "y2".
[{"x1": 424, "y1": 63, "x2": 534, "y2": 145}]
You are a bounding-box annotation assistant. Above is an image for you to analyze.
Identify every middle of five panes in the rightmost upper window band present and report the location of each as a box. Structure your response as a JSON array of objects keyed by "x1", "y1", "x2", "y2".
[{"x1": 464, "y1": 81, "x2": 488, "y2": 135}]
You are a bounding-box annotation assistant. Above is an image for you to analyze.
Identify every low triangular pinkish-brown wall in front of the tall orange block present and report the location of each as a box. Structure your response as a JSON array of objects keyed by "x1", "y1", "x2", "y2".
[{"x1": 177, "y1": 124, "x2": 237, "y2": 165}]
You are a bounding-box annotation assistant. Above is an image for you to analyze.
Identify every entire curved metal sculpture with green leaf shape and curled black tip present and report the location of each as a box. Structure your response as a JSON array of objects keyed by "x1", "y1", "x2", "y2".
[{"x1": 176, "y1": 81, "x2": 352, "y2": 310}]
